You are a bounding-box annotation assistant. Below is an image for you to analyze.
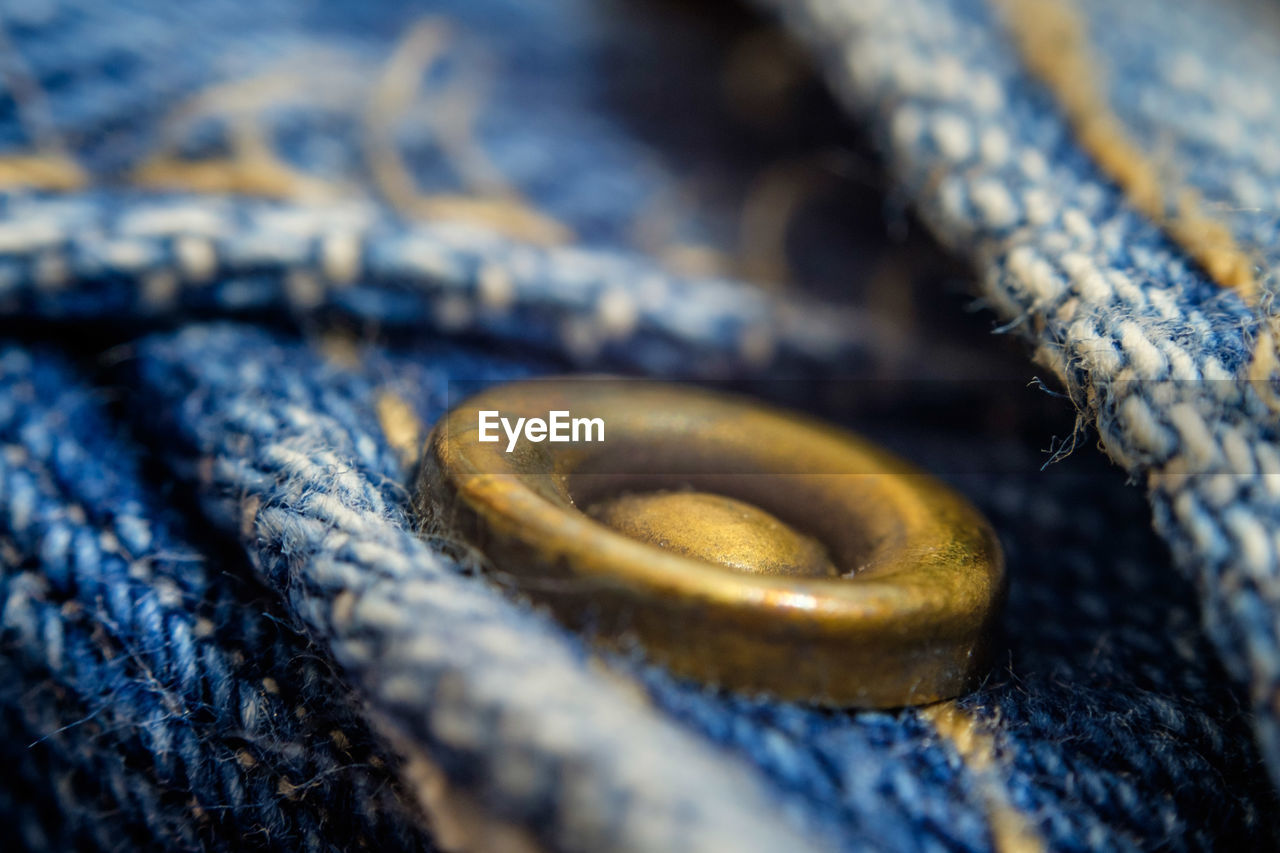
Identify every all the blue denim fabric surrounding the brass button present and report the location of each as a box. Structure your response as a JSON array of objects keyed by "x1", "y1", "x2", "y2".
[{"x1": 0, "y1": 0, "x2": 1280, "y2": 850}]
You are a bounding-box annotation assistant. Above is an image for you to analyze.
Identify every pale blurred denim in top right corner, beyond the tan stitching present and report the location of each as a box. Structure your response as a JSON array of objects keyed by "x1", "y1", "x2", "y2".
[{"x1": 1080, "y1": 3, "x2": 1280, "y2": 272}]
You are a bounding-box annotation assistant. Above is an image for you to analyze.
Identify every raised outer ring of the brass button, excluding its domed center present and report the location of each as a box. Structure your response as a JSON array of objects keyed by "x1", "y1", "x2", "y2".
[{"x1": 416, "y1": 377, "x2": 1005, "y2": 707}]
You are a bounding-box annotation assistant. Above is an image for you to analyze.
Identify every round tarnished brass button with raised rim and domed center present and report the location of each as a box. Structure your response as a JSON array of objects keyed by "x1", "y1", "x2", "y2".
[{"x1": 417, "y1": 379, "x2": 1004, "y2": 707}]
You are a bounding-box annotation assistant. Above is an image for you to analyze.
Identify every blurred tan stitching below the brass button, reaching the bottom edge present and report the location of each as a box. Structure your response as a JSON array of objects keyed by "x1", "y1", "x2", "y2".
[{"x1": 920, "y1": 702, "x2": 1044, "y2": 853}]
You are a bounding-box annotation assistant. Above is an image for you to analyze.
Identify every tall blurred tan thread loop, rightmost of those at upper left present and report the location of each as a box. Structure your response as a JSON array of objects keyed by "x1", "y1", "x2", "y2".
[{"x1": 365, "y1": 20, "x2": 572, "y2": 245}]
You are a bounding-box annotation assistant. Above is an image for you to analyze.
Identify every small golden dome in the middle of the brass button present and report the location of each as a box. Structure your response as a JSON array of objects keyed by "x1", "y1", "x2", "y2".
[{"x1": 588, "y1": 492, "x2": 840, "y2": 578}]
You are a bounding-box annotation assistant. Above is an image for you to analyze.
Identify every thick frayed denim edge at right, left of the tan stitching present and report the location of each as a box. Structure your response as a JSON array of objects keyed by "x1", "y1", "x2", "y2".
[{"x1": 767, "y1": 0, "x2": 1280, "y2": 780}]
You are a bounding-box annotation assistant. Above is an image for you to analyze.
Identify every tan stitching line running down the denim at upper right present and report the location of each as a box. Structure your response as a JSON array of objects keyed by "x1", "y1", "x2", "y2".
[{"x1": 996, "y1": 0, "x2": 1258, "y2": 295}]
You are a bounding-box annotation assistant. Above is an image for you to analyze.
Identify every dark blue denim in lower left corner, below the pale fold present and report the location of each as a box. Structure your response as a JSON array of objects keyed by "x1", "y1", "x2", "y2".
[{"x1": 0, "y1": 347, "x2": 433, "y2": 850}]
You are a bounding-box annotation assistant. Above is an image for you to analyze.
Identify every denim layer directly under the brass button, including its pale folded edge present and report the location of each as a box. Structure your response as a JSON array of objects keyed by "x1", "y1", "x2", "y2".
[{"x1": 120, "y1": 322, "x2": 1271, "y2": 850}]
